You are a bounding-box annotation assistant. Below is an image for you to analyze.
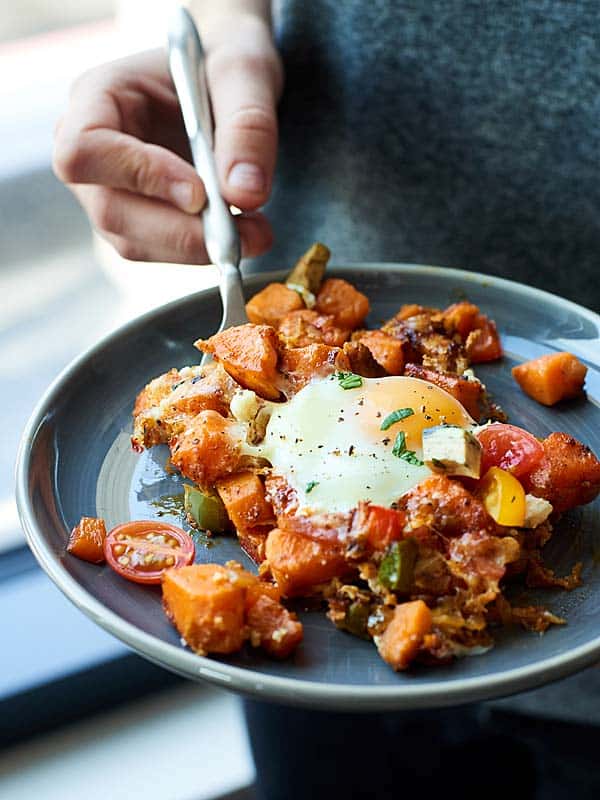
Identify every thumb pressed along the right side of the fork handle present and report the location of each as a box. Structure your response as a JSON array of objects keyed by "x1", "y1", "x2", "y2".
[{"x1": 207, "y1": 48, "x2": 281, "y2": 211}]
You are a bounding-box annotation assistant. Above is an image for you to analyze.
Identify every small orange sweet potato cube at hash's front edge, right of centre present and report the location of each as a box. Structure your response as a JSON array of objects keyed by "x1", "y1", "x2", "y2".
[{"x1": 376, "y1": 600, "x2": 431, "y2": 670}]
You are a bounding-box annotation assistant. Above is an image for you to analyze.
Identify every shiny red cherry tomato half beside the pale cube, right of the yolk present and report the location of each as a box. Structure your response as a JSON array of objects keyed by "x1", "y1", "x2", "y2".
[{"x1": 476, "y1": 422, "x2": 544, "y2": 478}]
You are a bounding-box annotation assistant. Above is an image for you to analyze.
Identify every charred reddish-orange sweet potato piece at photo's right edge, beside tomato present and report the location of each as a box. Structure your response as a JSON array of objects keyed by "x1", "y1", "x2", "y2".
[{"x1": 524, "y1": 433, "x2": 600, "y2": 512}]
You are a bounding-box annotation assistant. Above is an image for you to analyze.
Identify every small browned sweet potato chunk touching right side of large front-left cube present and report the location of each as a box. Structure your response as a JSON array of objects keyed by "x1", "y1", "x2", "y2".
[{"x1": 247, "y1": 593, "x2": 303, "y2": 658}]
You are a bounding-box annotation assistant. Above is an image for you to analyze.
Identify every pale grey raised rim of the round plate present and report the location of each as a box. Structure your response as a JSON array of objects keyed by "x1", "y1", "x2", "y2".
[{"x1": 15, "y1": 262, "x2": 600, "y2": 711}]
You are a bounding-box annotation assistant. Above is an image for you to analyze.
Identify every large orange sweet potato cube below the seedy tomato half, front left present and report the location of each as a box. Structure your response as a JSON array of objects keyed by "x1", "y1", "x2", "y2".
[{"x1": 162, "y1": 564, "x2": 247, "y2": 655}]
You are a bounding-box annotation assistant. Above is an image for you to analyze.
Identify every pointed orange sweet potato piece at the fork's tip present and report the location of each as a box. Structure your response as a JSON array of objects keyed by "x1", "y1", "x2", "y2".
[{"x1": 194, "y1": 323, "x2": 280, "y2": 400}]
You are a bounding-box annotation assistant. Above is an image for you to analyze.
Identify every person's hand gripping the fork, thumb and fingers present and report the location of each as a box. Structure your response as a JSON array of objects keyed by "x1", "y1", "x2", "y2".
[{"x1": 54, "y1": 18, "x2": 282, "y2": 264}]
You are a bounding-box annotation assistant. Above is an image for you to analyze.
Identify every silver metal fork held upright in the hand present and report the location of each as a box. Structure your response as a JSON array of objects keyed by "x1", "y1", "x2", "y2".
[{"x1": 169, "y1": 8, "x2": 248, "y2": 363}]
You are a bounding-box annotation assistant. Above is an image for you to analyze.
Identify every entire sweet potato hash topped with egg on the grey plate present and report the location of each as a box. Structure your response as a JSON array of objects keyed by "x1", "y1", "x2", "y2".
[{"x1": 69, "y1": 244, "x2": 600, "y2": 670}]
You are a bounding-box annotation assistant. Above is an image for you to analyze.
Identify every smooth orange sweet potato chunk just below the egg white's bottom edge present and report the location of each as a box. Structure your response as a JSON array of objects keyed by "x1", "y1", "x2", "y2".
[{"x1": 266, "y1": 528, "x2": 348, "y2": 597}]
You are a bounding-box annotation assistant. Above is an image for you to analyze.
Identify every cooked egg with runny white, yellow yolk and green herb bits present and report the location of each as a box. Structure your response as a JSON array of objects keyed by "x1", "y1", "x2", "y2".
[{"x1": 258, "y1": 376, "x2": 474, "y2": 513}]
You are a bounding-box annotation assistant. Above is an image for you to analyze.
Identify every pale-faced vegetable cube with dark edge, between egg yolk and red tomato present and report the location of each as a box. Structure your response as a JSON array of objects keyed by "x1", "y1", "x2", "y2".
[{"x1": 423, "y1": 425, "x2": 482, "y2": 478}]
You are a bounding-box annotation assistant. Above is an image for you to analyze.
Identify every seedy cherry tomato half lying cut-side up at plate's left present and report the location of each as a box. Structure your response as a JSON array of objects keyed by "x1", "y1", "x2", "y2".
[{"x1": 104, "y1": 520, "x2": 195, "y2": 583}]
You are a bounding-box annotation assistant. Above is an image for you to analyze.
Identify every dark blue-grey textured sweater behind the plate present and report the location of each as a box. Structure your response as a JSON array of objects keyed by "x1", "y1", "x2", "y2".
[{"x1": 254, "y1": 0, "x2": 600, "y2": 310}]
